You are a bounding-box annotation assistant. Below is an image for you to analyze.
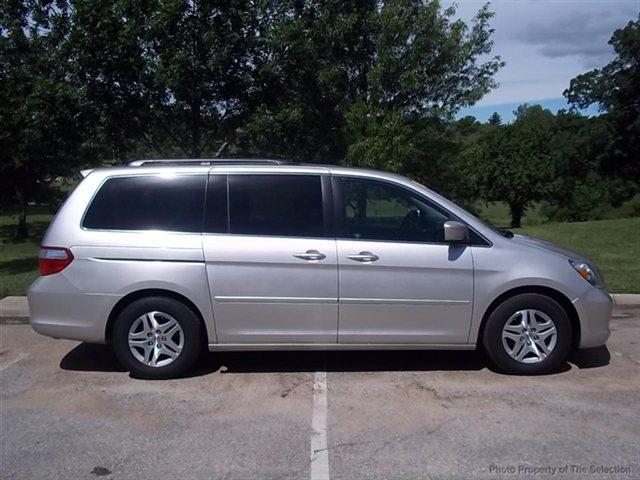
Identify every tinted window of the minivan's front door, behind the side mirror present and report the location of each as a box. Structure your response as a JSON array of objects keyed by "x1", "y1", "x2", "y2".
[{"x1": 340, "y1": 177, "x2": 451, "y2": 243}]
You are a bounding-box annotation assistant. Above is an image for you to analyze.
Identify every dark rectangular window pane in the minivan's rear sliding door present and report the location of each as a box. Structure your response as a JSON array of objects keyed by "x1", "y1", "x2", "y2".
[{"x1": 229, "y1": 175, "x2": 325, "y2": 237}]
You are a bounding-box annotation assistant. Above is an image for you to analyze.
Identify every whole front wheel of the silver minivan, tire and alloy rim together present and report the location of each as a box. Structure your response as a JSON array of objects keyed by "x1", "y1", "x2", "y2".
[{"x1": 482, "y1": 293, "x2": 571, "y2": 375}]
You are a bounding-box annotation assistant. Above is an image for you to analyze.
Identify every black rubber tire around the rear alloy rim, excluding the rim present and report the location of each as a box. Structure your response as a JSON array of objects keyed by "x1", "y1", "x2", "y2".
[{"x1": 113, "y1": 297, "x2": 205, "y2": 379}]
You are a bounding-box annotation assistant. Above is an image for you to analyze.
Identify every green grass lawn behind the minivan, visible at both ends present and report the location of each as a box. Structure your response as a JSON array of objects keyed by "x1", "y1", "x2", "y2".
[{"x1": 0, "y1": 212, "x2": 640, "y2": 298}]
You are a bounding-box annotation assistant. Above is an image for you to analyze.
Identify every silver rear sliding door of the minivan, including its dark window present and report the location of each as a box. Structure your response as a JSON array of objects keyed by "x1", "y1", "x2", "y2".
[{"x1": 203, "y1": 168, "x2": 338, "y2": 344}]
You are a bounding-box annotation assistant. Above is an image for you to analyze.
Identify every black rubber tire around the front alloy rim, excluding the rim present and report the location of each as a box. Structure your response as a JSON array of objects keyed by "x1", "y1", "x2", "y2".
[{"x1": 482, "y1": 293, "x2": 571, "y2": 375}]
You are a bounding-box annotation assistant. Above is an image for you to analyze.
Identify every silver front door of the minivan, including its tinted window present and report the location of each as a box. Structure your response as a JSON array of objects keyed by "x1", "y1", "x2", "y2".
[{"x1": 333, "y1": 177, "x2": 473, "y2": 344}]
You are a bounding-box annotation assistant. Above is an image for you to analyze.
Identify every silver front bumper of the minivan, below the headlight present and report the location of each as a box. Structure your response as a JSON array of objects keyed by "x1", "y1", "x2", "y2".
[{"x1": 573, "y1": 288, "x2": 613, "y2": 348}]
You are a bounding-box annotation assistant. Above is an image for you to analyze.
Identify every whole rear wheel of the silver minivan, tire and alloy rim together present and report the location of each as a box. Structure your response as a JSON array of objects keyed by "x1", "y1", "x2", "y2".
[{"x1": 113, "y1": 297, "x2": 204, "y2": 379}]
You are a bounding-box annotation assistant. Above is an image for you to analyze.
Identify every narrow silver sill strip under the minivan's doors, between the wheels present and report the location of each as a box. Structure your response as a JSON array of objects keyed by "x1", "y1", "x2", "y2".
[{"x1": 209, "y1": 343, "x2": 476, "y2": 352}]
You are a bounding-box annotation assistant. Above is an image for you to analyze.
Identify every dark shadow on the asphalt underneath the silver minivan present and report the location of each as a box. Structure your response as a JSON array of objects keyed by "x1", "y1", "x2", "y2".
[{"x1": 60, "y1": 343, "x2": 611, "y2": 378}]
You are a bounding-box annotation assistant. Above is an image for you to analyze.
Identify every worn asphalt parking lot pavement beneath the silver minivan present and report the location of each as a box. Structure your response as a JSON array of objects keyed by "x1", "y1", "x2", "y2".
[{"x1": 0, "y1": 309, "x2": 640, "y2": 479}]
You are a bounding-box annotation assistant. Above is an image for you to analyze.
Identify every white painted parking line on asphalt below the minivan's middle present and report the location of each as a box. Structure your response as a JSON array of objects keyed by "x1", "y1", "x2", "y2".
[{"x1": 311, "y1": 372, "x2": 329, "y2": 480}]
